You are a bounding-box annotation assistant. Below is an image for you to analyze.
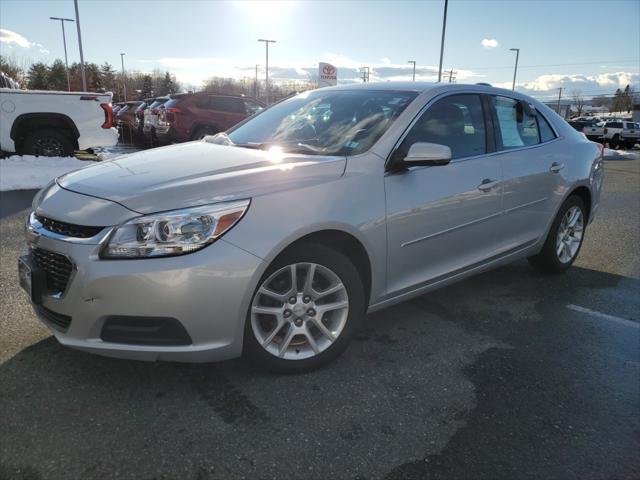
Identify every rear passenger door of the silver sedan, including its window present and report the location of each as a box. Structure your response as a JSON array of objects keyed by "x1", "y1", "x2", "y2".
[{"x1": 489, "y1": 96, "x2": 570, "y2": 249}]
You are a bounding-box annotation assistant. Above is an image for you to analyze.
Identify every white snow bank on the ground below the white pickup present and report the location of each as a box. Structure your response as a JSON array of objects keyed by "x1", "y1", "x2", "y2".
[{"x1": 0, "y1": 155, "x2": 94, "y2": 191}]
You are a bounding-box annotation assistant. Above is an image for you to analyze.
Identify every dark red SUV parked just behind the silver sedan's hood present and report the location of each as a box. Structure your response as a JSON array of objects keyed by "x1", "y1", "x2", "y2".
[{"x1": 156, "y1": 92, "x2": 264, "y2": 143}]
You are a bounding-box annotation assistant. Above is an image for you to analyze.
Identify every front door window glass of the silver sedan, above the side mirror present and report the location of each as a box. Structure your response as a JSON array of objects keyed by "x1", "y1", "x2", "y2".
[{"x1": 400, "y1": 94, "x2": 487, "y2": 158}]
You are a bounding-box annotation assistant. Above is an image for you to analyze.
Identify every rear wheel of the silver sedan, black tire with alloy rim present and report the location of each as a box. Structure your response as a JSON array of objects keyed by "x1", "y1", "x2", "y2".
[{"x1": 529, "y1": 195, "x2": 588, "y2": 273}]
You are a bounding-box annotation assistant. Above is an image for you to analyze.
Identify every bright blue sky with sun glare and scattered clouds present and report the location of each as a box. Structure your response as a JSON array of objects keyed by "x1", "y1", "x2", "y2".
[{"x1": 0, "y1": 0, "x2": 640, "y2": 100}]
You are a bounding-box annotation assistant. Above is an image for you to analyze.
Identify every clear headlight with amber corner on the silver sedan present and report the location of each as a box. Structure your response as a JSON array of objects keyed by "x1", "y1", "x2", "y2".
[{"x1": 101, "y1": 200, "x2": 249, "y2": 258}]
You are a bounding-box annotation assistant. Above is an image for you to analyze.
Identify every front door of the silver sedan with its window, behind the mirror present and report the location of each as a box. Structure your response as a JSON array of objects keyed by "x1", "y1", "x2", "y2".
[{"x1": 385, "y1": 94, "x2": 502, "y2": 294}]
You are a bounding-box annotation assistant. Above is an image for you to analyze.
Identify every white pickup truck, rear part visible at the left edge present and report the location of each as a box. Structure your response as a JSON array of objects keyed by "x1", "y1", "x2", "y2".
[{"x1": 0, "y1": 82, "x2": 118, "y2": 157}]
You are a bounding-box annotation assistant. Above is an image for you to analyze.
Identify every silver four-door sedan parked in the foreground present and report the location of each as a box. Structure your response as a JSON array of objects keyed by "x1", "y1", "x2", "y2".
[{"x1": 19, "y1": 83, "x2": 603, "y2": 372}]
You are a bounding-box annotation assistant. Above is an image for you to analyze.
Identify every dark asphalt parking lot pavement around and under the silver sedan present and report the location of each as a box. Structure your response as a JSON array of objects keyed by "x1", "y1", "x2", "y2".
[{"x1": 0, "y1": 159, "x2": 640, "y2": 479}]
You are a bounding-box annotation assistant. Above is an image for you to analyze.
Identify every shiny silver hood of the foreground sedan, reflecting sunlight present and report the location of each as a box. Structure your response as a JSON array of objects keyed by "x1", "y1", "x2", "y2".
[{"x1": 57, "y1": 141, "x2": 346, "y2": 213}]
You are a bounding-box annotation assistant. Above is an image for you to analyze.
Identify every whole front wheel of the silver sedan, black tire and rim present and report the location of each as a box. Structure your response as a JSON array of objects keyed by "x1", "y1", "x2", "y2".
[{"x1": 244, "y1": 243, "x2": 365, "y2": 373}]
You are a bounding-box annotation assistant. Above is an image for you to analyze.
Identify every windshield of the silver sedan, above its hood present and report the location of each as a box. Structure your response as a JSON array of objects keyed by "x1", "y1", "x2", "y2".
[{"x1": 219, "y1": 90, "x2": 417, "y2": 155}]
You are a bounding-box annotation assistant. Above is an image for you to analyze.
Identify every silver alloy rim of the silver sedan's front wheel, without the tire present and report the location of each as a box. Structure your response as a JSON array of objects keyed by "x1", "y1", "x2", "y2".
[{"x1": 251, "y1": 263, "x2": 349, "y2": 360}]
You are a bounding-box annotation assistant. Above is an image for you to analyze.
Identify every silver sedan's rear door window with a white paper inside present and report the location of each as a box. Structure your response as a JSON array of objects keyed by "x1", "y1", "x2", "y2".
[{"x1": 494, "y1": 97, "x2": 540, "y2": 150}]
